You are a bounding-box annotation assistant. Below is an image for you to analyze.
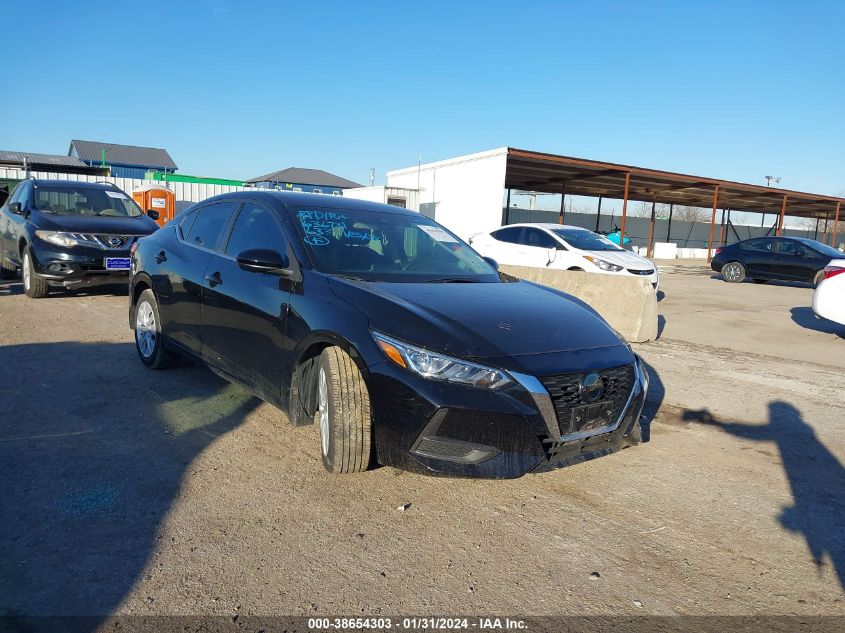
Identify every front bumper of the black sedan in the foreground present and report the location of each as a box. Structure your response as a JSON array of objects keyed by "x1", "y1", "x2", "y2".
[{"x1": 369, "y1": 354, "x2": 647, "y2": 479}]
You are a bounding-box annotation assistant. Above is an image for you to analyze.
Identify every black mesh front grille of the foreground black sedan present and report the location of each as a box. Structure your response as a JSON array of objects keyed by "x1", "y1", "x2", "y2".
[{"x1": 540, "y1": 365, "x2": 634, "y2": 435}]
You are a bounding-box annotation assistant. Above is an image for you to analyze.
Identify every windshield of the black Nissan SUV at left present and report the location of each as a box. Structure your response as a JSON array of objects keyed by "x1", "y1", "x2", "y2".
[{"x1": 34, "y1": 184, "x2": 141, "y2": 218}]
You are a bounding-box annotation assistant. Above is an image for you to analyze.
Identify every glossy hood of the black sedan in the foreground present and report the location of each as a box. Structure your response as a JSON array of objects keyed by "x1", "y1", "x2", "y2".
[{"x1": 329, "y1": 277, "x2": 625, "y2": 358}]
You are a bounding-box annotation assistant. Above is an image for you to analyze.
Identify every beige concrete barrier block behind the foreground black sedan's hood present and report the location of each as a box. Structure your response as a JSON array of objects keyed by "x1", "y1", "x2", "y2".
[{"x1": 499, "y1": 266, "x2": 657, "y2": 343}]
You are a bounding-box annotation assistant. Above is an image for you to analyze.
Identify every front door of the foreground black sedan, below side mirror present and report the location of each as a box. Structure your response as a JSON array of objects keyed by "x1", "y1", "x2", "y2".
[{"x1": 202, "y1": 201, "x2": 295, "y2": 397}]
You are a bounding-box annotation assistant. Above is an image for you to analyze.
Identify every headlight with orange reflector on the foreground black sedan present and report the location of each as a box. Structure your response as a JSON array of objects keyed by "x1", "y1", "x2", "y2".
[{"x1": 372, "y1": 332, "x2": 513, "y2": 389}]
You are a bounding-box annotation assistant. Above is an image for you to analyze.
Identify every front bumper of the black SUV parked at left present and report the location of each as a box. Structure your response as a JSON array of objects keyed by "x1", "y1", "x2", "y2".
[{"x1": 30, "y1": 240, "x2": 130, "y2": 289}]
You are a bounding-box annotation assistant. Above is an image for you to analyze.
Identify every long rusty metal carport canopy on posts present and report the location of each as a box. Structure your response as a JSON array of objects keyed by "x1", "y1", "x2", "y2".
[{"x1": 505, "y1": 147, "x2": 845, "y2": 250}]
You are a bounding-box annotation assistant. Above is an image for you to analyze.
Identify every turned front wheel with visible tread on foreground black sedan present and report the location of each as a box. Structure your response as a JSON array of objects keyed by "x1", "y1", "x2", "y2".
[{"x1": 315, "y1": 347, "x2": 372, "y2": 474}]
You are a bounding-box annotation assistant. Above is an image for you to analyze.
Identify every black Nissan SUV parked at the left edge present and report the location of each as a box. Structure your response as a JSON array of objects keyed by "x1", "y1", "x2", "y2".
[{"x1": 0, "y1": 179, "x2": 158, "y2": 299}]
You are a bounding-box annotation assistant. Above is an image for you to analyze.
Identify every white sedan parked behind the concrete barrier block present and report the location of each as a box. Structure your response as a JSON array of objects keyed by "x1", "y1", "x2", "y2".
[{"x1": 469, "y1": 224, "x2": 659, "y2": 290}]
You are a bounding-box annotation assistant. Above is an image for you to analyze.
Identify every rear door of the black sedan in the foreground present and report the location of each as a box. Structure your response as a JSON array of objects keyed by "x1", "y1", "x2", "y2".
[{"x1": 160, "y1": 200, "x2": 240, "y2": 355}]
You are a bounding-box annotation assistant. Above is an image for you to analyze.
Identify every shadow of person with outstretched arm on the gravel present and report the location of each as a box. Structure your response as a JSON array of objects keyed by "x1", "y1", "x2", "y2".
[{"x1": 683, "y1": 401, "x2": 845, "y2": 588}]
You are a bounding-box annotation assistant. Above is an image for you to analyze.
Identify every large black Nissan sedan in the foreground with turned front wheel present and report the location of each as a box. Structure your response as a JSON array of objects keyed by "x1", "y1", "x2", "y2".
[{"x1": 129, "y1": 192, "x2": 648, "y2": 478}]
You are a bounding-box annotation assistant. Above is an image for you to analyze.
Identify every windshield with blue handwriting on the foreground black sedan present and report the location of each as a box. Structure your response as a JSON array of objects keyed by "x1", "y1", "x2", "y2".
[{"x1": 293, "y1": 208, "x2": 499, "y2": 282}]
